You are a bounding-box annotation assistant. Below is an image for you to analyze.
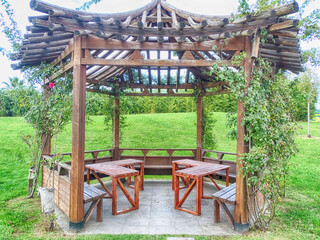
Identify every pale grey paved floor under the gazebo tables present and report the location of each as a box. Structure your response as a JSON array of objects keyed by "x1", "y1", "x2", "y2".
[{"x1": 57, "y1": 181, "x2": 236, "y2": 235}]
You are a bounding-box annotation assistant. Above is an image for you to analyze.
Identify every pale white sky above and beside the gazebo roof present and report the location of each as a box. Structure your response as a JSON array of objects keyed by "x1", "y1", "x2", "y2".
[{"x1": 0, "y1": 0, "x2": 320, "y2": 109}]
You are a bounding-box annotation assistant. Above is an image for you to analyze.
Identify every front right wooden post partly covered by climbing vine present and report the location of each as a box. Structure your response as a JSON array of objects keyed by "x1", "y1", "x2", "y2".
[{"x1": 234, "y1": 37, "x2": 252, "y2": 231}]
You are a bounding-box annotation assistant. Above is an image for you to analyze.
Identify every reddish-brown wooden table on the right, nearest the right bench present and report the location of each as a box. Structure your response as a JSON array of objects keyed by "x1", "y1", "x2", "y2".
[{"x1": 172, "y1": 159, "x2": 230, "y2": 215}]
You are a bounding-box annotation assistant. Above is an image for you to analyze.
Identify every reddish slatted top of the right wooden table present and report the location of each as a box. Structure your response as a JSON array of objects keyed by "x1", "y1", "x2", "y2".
[{"x1": 173, "y1": 159, "x2": 230, "y2": 177}]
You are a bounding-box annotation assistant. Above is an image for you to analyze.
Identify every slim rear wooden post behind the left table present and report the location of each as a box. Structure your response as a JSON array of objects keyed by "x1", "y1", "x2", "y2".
[{"x1": 113, "y1": 96, "x2": 120, "y2": 160}]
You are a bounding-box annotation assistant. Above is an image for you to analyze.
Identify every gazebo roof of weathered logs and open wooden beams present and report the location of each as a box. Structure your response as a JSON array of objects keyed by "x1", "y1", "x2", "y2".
[{"x1": 12, "y1": 0, "x2": 302, "y2": 94}]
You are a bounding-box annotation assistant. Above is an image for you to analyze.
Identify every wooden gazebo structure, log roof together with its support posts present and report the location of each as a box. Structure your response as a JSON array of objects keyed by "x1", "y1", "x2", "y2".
[{"x1": 11, "y1": 0, "x2": 302, "y2": 230}]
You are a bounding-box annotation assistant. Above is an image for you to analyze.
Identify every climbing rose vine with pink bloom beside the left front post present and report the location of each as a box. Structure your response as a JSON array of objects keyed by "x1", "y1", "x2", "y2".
[{"x1": 21, "y1": 64, "x2": 72, "y2": 197}]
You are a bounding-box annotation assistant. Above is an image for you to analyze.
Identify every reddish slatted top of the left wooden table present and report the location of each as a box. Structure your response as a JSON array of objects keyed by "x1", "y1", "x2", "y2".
[{"x1": 86, "y1": 160, "x2": 139, "y2": 177}]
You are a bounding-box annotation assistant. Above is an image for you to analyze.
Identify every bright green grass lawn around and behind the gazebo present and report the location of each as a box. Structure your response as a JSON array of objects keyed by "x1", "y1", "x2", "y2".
[{"x1": 0, "y1": 113, "x2": 320, "y2": 239}]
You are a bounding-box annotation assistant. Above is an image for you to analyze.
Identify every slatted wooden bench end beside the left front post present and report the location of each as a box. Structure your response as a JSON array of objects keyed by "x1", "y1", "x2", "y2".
[{"x1": 83, "y1": 183, "x2": 106, "y2": 224}]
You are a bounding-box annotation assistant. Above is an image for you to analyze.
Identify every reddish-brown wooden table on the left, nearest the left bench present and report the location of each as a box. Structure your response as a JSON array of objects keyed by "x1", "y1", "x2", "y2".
[{"x1": 86, "y1": 159, "x2": 144, "y2": 215}]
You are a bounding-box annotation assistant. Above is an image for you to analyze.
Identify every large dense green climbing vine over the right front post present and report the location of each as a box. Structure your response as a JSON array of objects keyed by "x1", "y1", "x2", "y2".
[{"x1": 213, "y1": 55, "x2": 297, "y2": 229}]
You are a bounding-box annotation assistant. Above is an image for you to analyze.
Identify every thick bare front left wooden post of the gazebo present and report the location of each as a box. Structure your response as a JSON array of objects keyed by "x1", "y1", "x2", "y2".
[{"x1": 69, "y1": 37, "x2": 86, "y2": 230}]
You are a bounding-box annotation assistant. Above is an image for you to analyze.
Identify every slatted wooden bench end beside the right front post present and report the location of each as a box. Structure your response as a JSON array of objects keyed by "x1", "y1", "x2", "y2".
[{"x1": 212, "y1": 183, "x2": 236, "y2": 228}]
